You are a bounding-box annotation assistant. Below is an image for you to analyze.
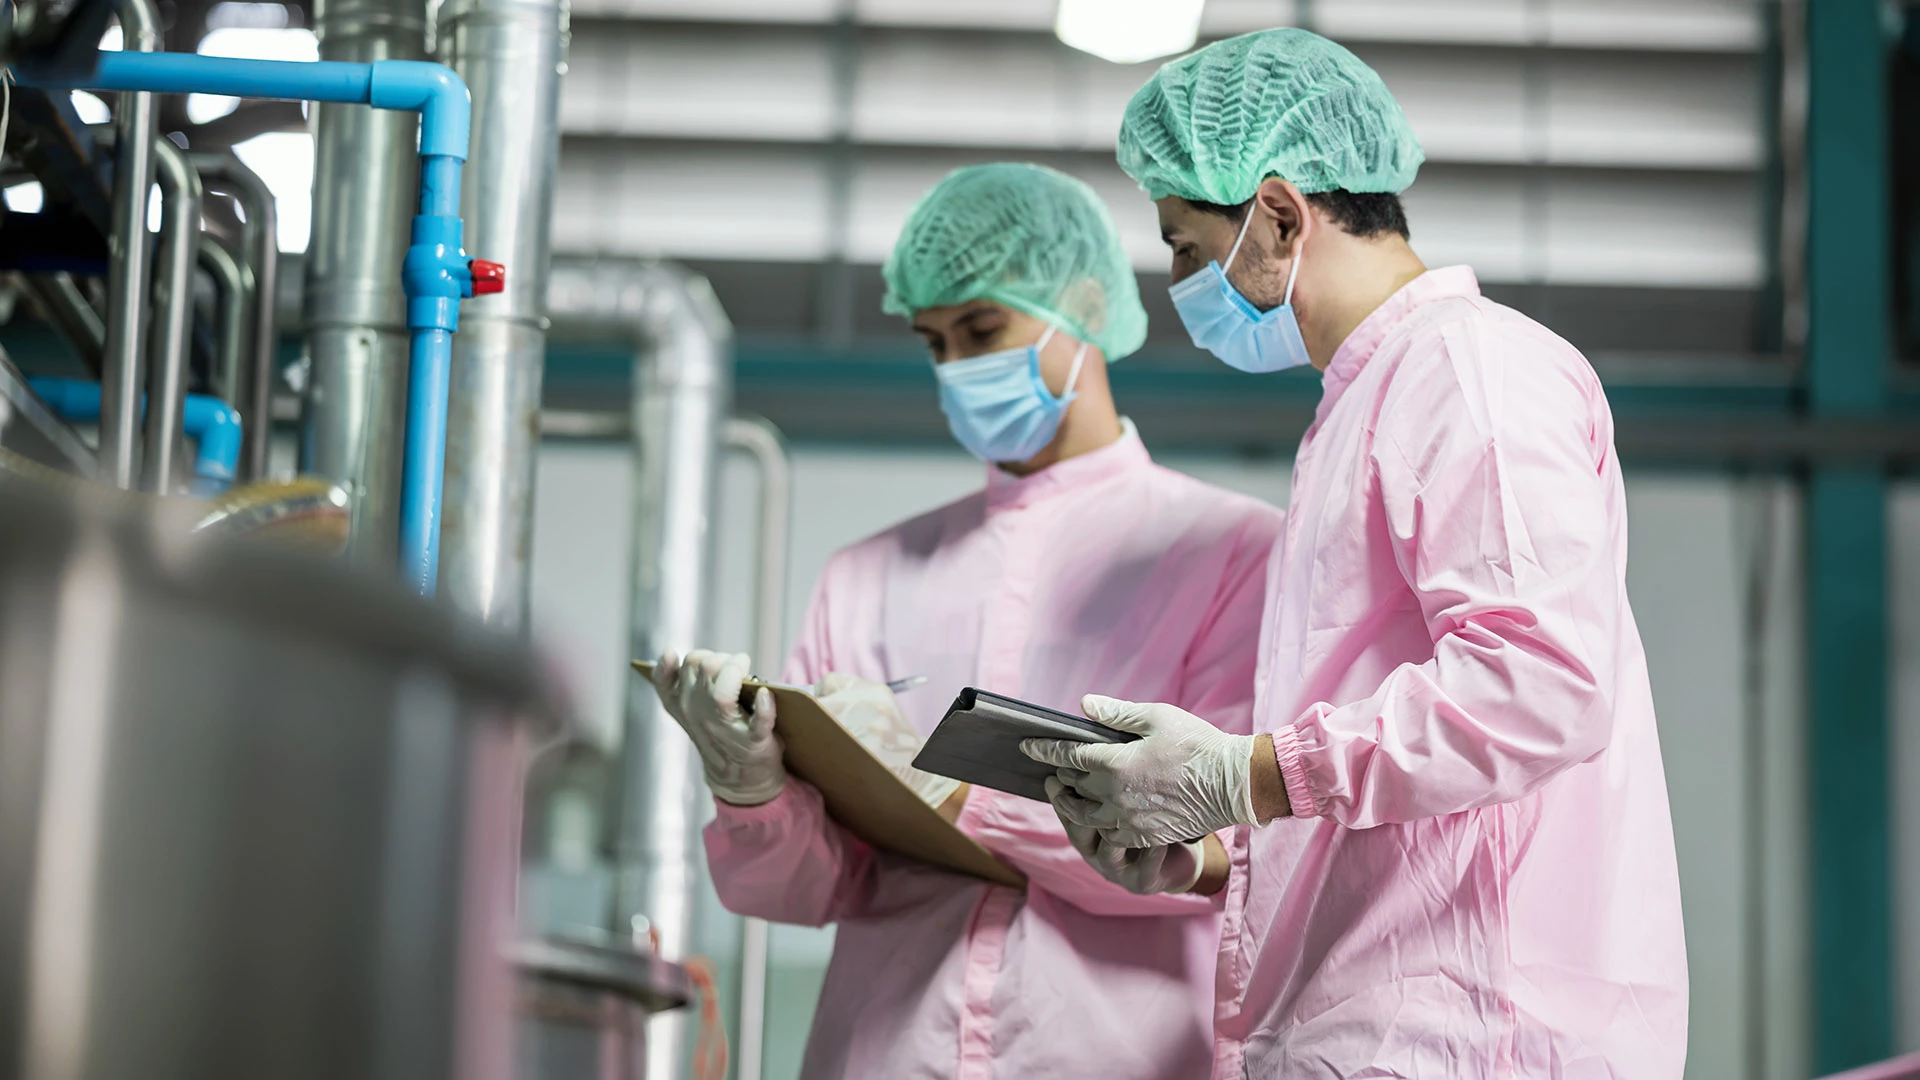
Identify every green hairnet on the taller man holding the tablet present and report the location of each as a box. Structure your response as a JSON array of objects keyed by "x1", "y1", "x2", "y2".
[{"x1": 1119, "y1": 29, "x2": 1425, "y2": 206}]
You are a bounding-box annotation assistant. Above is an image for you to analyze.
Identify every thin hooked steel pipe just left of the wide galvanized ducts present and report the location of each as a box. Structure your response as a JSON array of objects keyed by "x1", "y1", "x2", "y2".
[{"x1": 192, "y1": 154, "x2": 280, "y2": 480}]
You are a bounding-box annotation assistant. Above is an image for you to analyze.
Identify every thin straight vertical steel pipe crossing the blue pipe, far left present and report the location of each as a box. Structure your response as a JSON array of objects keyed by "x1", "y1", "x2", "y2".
[{"x1": 100, "y1": 0, "x2": 159, "y2": 490}]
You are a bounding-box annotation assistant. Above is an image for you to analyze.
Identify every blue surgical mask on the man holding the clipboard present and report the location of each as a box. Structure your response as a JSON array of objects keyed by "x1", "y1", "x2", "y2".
[{"x1": 933, "y1": 327, "x2": 1087, "y2": 461}]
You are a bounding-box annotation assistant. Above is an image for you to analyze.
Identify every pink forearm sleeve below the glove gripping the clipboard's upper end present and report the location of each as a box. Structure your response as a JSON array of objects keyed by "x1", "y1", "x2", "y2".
[{"x1": 707, "y1": 778, "x2": 874, "y2": 926}]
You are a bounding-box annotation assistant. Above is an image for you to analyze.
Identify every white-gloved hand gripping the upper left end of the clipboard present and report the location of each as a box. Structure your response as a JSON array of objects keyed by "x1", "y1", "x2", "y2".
[{"x1": 653, "y1": 650, "x2": 787, "y2": 807}]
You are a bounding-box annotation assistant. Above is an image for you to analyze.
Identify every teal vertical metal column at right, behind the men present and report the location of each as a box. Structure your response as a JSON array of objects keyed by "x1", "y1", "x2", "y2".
[{"x1": 1805, "y1": 0, "x2": 1893, "y2": 1076}]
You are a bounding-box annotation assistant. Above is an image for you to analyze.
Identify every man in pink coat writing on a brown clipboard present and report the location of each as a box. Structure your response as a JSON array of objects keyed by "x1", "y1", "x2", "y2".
[{"x1": 655, "y1": 165, "x2": 1281, "y2": 1080}]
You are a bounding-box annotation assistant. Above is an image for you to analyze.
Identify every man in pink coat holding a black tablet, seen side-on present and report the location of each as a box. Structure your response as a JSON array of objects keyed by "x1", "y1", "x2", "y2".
[{"x1": 1027, "y1": 31, "x2": 1688, "y2": 1080}]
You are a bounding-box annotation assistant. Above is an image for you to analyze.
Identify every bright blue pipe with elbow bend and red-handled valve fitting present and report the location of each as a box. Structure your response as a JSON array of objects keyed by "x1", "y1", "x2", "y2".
[{"x1": 15, "y1": 52, "x2": 472, "y2": 596}]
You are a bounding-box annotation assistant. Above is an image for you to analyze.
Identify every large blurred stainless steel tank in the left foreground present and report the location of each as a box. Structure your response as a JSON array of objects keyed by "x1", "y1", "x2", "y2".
[{"x1": 0, "y1": 484, "x2": 547, "y2": 1080}]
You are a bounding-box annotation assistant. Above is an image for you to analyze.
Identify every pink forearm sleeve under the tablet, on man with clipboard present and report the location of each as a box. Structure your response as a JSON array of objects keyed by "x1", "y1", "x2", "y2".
[{"x1": 954, "y1": 788, "x2": 1215, "y2": 915}]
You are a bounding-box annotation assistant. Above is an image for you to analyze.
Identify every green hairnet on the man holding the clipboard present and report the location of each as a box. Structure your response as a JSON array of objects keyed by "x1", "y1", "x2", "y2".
[{"x1": 881, "y1": 163, "x2": 1146, "y2": 361}]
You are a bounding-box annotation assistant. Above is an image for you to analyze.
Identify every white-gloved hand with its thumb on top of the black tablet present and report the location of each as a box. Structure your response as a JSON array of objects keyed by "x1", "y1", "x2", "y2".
[{"x1": 1020, "y1": 694, "x2": 1258, "y2": 847}]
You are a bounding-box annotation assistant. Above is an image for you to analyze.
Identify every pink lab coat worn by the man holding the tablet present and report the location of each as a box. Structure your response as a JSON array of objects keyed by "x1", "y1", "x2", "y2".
[{"x1": 1213, "y1": 267, "x2": 1688, "y2": 1080}]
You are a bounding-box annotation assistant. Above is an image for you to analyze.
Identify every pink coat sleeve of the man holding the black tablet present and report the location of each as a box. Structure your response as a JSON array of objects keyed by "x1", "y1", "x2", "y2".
[{"x1": 1275, "y1": 321, "x2": 1626, "y2": 828}]
